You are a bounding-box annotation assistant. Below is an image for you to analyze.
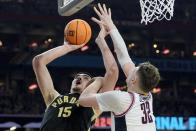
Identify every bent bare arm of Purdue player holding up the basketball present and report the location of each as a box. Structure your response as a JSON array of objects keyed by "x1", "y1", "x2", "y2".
[{"x1": 33, "y1": 42, "x2": 83, "y2": 107}]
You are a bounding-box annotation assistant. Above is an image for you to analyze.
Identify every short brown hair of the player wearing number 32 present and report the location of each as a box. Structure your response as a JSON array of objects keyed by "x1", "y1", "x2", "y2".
[{"x1": 137, "y1": 62, "x2": 160, "y2": 93}]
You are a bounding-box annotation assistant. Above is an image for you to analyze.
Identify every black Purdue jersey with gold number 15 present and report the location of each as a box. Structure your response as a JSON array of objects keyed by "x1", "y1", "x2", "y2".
[{"x1": 40, "y1": 93, "x2": 96, "y2": 131}]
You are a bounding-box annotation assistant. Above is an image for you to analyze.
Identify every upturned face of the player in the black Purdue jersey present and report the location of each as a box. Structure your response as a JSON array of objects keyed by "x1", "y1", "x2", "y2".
[{"x1": 71, "y1": 74, "x2": 91, "y2": 93}]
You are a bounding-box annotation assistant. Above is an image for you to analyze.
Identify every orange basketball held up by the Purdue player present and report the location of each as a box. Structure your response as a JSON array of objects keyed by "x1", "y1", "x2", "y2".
[{"x1": 64, "y1": 19, "x2": 91, "y2": 45}]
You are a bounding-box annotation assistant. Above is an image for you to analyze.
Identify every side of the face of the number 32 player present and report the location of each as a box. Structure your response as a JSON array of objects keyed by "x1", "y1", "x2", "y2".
[{"x1": 126, "y1": 67, "x2": 139, "y2": 88}]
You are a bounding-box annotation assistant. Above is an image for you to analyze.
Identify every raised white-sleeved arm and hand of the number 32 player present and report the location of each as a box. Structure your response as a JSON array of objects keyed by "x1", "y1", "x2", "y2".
[{"x1": 93, "y1": 4, "x2": 135, "y2": 76}]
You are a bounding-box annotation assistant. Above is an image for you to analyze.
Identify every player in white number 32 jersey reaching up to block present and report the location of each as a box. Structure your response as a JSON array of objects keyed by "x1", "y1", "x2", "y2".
[{"x1": 79, "y1": 4, "x2": 160, "y2": 131}]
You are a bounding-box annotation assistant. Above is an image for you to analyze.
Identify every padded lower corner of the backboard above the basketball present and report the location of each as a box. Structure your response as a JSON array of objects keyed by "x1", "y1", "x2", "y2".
[{"x1": 58, "y1": 0, "x2": 94, "y2": 16}]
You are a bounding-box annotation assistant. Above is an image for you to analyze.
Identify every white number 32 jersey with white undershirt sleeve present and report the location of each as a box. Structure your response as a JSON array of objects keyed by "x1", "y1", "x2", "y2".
[{"x1": 96, "y1": 91, "x2": 156, "y2": 131}]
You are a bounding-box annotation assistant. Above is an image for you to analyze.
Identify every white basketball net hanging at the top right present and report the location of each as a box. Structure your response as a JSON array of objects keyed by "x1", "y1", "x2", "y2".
[{"x1": 140, "y1": 0, "x2": 175, "y2": 25}]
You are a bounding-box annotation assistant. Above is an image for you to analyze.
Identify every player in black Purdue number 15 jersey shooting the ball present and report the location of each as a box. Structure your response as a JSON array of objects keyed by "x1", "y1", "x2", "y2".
[{"x1": 33, "y1": 18, "x2": 118, "y2": 131}]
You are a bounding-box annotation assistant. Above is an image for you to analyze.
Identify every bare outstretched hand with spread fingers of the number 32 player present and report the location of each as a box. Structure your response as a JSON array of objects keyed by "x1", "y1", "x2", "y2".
[{"x1": 91, "y1": 3, "x2": 116, "y2": 31}]
